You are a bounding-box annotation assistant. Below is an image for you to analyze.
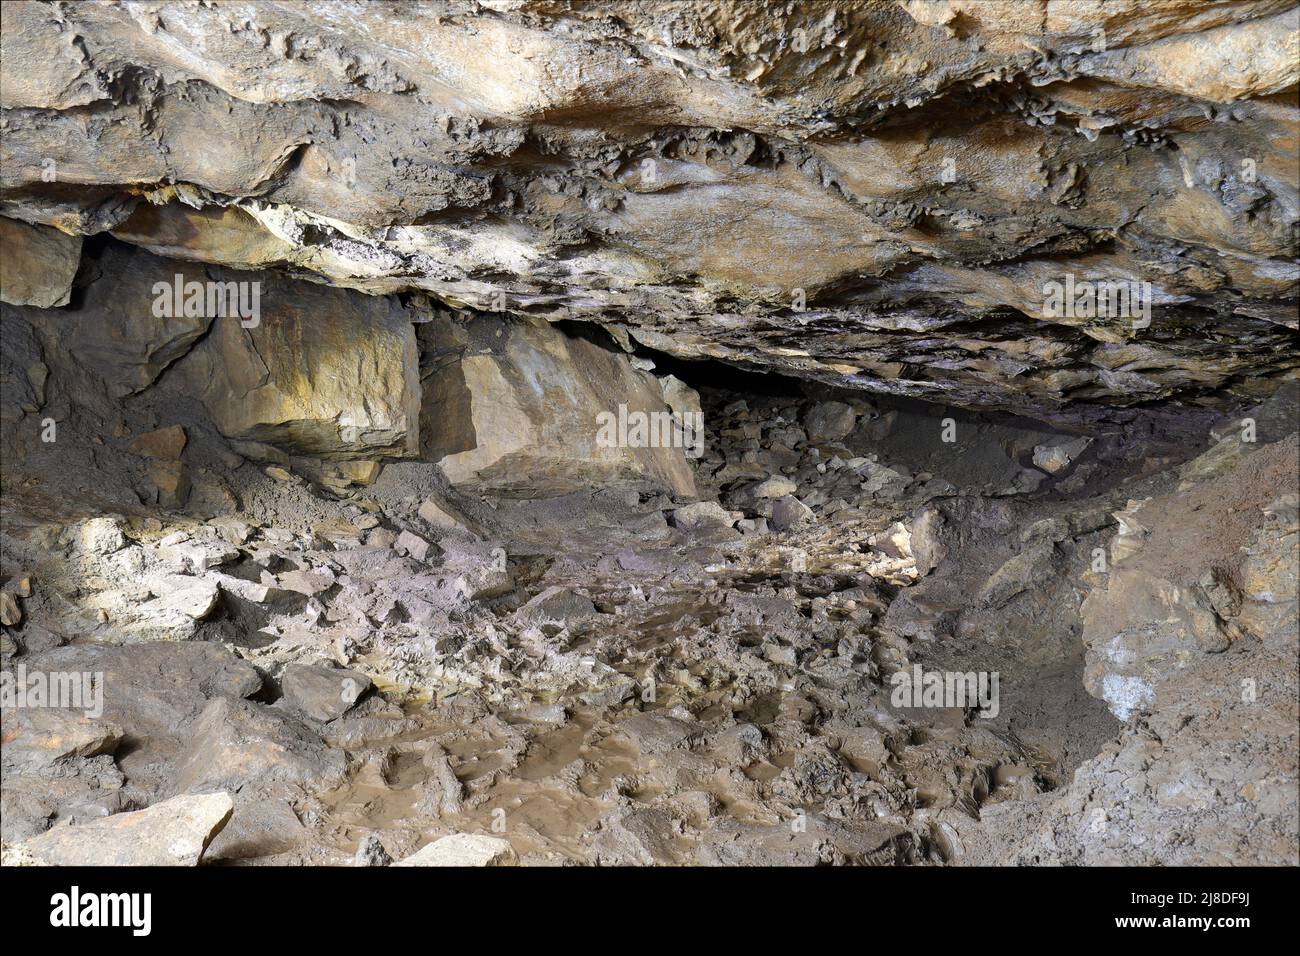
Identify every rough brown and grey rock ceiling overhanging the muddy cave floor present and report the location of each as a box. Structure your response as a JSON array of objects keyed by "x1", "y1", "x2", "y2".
[{"x1": 0, "y1": 0, "x2": 1300, "y2": 413}]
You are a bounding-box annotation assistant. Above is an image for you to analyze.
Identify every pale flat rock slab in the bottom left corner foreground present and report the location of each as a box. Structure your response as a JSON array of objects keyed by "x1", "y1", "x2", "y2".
[{"x1": 23, "y1": 793, "x2": 234, "y2": 866}]
